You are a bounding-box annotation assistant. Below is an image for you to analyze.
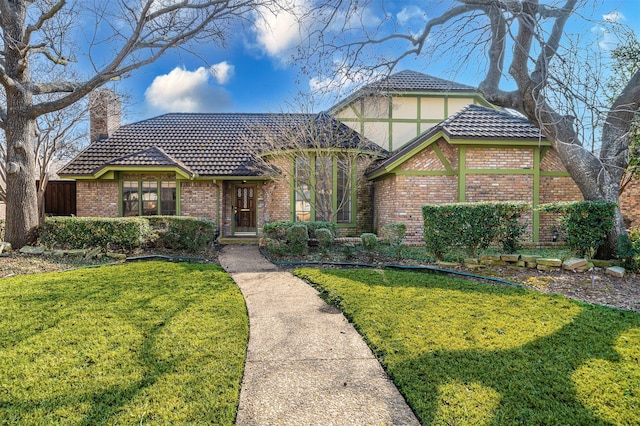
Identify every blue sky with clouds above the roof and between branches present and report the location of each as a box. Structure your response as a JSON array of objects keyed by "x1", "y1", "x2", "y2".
[{"x1": 104, "y1": 0, "x2": 640, "y2": 123}]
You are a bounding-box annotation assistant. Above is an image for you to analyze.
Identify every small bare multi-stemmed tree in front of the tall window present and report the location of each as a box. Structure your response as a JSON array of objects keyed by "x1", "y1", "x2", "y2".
[{"x1": 247, "y1": 113, "x2": 383, "y2": 223}]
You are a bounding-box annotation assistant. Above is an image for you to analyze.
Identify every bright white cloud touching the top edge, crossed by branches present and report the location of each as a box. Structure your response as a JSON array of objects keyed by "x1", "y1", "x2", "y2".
[{"x1": 255, "y1": 0, "x2": 310, "y2": 59}]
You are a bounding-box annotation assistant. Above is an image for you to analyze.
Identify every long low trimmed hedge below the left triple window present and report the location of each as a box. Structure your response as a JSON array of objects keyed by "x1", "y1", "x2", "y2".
[{"x1": 40, "y1": 216, "x2": 216, "y2": 252}]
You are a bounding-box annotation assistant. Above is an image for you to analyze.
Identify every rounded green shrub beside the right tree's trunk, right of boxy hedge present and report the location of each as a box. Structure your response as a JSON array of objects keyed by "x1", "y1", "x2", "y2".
[{"x1": 540, "y1": 201, "x2": 617, "y2": 257}]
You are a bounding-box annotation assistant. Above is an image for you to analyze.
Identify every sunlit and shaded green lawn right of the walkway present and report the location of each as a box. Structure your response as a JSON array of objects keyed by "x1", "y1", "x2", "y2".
[{"x1": 296, "y1": 269, "x2": 640, "y2": 425}]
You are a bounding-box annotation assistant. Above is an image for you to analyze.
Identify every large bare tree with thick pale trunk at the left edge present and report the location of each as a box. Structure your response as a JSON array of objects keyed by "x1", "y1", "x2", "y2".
[{"x1": 0, "y1": 0, "x2": 278, "y2": 247}]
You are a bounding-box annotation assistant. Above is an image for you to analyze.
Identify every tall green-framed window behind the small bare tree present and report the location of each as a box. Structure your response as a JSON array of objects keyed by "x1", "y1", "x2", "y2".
[{"x1": 294, "y1": 156, "x2": 353, "y2": 224}]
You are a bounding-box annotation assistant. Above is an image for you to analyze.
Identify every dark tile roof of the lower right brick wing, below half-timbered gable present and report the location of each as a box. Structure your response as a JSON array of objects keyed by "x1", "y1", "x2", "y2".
[{"x1": 367, "y1": 104, "x2": 547, "y2": 175}]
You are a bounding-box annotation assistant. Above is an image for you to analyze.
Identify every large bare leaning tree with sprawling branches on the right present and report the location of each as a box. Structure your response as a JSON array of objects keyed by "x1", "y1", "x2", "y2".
[{"x1": 309, "y1": 0, "x2": 640, "y2": 257}]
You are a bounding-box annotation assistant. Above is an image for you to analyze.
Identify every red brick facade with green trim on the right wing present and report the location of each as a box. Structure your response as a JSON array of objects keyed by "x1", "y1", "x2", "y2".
[{"x1": 374, "y1": 140, "x2": 582, "y2": 244}]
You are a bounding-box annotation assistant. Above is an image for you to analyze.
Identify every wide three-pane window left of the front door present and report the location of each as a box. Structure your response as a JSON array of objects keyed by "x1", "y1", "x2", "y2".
[{"x1": 122, "y1": 180, "x2": 177, "y2": 216}]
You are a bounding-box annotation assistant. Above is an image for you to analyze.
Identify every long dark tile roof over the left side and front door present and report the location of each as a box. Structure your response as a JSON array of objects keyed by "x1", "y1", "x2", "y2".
[{"x1": 59, "y1": 113, "x2": 380, "y2": 177}]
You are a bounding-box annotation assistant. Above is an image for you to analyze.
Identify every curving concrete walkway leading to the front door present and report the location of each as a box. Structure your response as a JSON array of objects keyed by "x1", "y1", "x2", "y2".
[{"x1": 220, "y1": 245, "x2": 419, "y2": 426}]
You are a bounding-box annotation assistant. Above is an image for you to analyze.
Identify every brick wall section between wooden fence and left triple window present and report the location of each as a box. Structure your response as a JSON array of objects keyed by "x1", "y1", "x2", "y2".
[{"x1": 76, "y1": 180, "x2": 120, "y2": 217}]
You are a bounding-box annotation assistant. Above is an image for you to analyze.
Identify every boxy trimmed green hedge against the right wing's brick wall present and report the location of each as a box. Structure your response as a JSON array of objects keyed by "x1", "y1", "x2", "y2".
[{"x1": 422, "y1": 203, "x2": 530, "y2": 259}]
